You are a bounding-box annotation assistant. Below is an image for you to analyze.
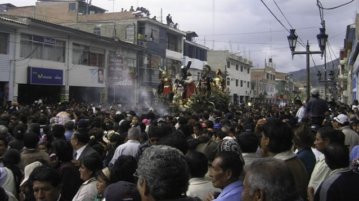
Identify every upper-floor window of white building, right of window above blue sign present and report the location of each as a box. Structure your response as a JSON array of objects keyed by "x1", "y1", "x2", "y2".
[{"x1": 72, "y1": 43, "x2": 105, "y2": 67}]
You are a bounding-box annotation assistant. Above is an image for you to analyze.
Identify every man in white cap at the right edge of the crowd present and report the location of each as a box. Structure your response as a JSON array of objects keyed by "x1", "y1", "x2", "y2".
[{"x1": 332, "y1": 114, "x2": 359, "y2": 152}]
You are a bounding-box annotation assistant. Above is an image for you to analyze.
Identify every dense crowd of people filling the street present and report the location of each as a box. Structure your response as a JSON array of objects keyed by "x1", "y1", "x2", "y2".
[{"x1": 0, "y1": 89, "x2": 359, "y2": 201}]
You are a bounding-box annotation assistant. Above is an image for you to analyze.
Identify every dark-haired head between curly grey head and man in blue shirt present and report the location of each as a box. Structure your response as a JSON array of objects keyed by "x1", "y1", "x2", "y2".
[{"x1": 186, "y1": 151, "x2": 208, "y2": 178}]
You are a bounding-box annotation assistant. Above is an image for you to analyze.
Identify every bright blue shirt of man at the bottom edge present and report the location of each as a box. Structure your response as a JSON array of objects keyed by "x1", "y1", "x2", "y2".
[{"x1": 215, "y1": 180, "x2": 243, "y2": 201}]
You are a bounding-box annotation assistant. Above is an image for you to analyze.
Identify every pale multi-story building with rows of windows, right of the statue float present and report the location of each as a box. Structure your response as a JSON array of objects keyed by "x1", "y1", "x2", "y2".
[{"x1": 207, "y1": 50, "x2": 252, "y2": 103}]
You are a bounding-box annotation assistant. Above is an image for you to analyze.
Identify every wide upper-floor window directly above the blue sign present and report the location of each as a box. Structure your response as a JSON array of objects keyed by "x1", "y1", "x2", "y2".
[{"x1": 20, "y1": 34, "x2": 66, "y2": 62}]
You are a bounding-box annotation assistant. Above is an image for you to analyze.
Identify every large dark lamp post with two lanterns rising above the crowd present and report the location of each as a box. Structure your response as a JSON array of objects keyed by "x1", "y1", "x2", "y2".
[{"x1": 287, "y1": 28, "x2": 328, "y2": 100}]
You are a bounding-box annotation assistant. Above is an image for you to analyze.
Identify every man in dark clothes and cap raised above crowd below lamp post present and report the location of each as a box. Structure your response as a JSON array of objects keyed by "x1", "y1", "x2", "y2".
[{"x1": 305, "y1": 88, "x2": 329, "y2": 125}]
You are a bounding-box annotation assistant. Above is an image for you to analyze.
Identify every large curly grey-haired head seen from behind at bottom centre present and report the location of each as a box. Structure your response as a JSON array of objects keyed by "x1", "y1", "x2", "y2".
[{"x1": 136, "y1": 145, "x2": 189, "y2": 201}]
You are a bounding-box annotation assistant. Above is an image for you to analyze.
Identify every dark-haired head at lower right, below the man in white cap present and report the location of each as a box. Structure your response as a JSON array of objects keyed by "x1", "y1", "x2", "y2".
[{"x1": 323, "y1": 143, "x2": 349, "y2": 170}]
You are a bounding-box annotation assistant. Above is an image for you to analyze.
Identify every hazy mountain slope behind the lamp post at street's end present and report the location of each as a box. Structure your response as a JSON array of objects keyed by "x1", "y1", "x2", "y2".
[{"x1": 288, "y1": 59, "x2": 339, "y2": 86}]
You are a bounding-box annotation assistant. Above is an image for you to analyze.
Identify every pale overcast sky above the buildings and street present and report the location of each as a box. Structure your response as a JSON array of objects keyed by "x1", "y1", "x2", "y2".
[{"x1": 0, "y1": 0, "x2": 359, "y2": 72}]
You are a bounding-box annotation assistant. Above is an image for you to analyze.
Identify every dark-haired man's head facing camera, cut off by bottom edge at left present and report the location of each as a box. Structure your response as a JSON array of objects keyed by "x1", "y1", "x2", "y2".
[{"x1": 29, "y1": 166, "x2": 61, "y2": 201}]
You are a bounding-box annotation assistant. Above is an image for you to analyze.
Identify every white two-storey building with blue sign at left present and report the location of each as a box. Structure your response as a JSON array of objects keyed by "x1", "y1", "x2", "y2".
[{"x1": 0, "y1": 15, "x2": 143, "y2": 103}]
